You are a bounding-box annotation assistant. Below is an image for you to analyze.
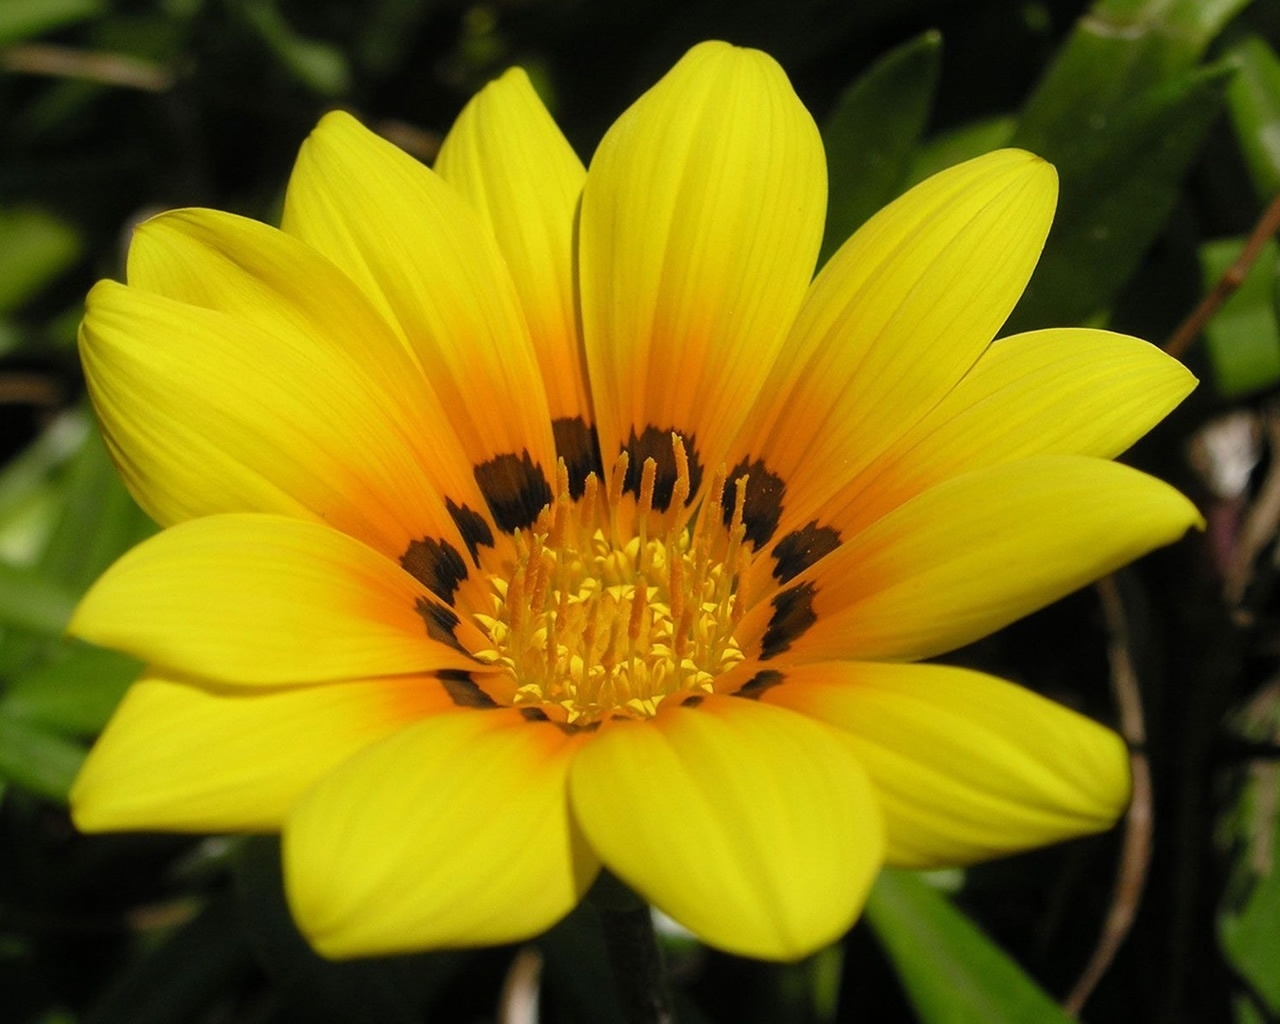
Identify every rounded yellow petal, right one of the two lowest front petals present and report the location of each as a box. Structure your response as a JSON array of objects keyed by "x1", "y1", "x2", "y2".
[{"x1": 571, "y1": 696, "x2": 883, "y2": 960}]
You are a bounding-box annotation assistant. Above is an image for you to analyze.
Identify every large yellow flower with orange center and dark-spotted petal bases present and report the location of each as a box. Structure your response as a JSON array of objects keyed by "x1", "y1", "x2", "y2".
[{"x1": 72, "y1": 44, "x2": 1199, "y2": 959}]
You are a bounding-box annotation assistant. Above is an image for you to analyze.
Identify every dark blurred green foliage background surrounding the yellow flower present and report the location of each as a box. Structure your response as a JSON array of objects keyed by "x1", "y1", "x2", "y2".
[{"x1": 0, "y1": 0, "x2": 1280, "y2": 1024}]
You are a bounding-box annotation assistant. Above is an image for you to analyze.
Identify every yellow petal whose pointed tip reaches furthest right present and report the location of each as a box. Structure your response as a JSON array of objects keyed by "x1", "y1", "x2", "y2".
[{"x1": 739, "y1": 456, "x2": 1202, "y2": 660}]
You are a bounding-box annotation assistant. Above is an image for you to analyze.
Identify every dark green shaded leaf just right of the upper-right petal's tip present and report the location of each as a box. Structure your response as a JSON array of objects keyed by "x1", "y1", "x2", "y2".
[{"x1": 1007, "y1": 65, "x2": 1231, "y2": 332}]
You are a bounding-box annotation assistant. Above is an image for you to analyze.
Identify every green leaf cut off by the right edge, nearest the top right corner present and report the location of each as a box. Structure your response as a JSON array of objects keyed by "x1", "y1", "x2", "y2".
[{"x1": 1225, "y1": 36, "x2": 1280, "y2": 202}]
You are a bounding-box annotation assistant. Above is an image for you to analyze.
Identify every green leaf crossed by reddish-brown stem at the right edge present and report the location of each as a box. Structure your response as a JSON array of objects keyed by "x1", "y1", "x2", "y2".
[{"x1": 1199, "y1": 238, "x2": 1280, "y2": 396}]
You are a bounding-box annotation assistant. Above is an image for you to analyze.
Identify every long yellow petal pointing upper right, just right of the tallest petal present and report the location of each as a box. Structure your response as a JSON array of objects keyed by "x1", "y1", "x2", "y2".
[{"x1": 733, "y1": 150, "x2": 1057, "y2": 542}]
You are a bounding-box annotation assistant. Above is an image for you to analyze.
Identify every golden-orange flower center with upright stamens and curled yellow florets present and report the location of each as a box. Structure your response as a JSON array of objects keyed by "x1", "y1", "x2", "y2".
[{"x1": 474, "y1": 434, "x2": 750, "y2": 727}]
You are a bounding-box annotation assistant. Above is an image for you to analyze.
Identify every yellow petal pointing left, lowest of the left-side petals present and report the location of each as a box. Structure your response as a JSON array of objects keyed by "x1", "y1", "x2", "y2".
[{"x1": 70, "y1": 675, "x2": 453, "y2": 832}]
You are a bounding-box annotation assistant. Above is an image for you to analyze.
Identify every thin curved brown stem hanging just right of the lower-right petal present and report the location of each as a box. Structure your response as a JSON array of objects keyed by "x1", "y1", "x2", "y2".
[{"x1": 1062, "y1": 576, "x2": 1155, "y2": 1016}]
